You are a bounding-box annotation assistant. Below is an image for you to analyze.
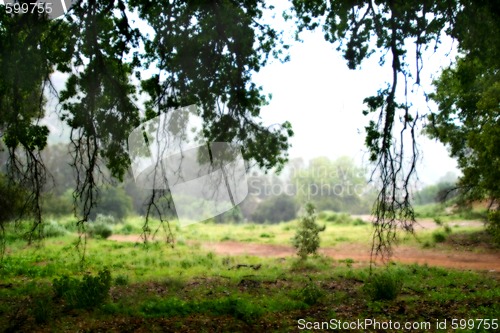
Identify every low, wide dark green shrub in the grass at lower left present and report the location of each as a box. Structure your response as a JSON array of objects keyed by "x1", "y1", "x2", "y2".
[{"x1": 52, "y1": 269, "x2": 111, "y2": 309}]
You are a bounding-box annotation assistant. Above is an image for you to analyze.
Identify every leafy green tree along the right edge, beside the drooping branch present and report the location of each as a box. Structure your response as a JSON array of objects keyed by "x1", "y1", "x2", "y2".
[{"x1": 426, "y1": 1, "x2": 500, "y2": 239}]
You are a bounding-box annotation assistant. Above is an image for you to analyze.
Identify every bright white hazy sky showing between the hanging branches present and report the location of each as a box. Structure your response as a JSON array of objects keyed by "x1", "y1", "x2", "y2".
[{"x1": 44, "y1": 2, "x2": 458, "y2": 184}]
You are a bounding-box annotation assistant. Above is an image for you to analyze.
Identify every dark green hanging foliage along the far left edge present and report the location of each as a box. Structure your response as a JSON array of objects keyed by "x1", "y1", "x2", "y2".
[{"x1": 0, "y1": 8, "x2": 71, "y2": 242}]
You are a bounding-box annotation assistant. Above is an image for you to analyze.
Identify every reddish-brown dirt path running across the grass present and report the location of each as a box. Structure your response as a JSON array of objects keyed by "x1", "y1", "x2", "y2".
[{"x1": 108, "y1": 235, "x2": 500, "y2": 272}]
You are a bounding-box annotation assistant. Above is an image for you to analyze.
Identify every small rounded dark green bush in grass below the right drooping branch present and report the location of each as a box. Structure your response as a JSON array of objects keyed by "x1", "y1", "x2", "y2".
[{"x1": 365, "y1": 270, "x2": 403, "y2": 301}]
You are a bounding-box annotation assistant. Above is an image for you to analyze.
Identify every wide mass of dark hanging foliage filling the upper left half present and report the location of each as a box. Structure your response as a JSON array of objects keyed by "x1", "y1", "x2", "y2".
[{"x1": 0, "y1": 0, "x2": 293, "y2": 253}]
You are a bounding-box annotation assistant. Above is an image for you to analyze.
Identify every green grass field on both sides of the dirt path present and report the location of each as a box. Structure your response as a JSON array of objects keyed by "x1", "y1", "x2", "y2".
[{"x1": 0, "y1": 214, "x2": 500, "y2": 332}]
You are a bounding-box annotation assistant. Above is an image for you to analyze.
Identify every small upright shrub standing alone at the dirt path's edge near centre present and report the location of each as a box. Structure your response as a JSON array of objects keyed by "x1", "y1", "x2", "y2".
[{"x1": 292, "y1": 204, "x2": 325, "y2": 259}]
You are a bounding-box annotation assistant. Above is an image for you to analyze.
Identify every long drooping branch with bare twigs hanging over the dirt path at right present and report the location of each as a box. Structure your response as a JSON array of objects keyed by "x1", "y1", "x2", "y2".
[{"x1": 292, "y1": 0, "x2": 460, "y2": 260}]
